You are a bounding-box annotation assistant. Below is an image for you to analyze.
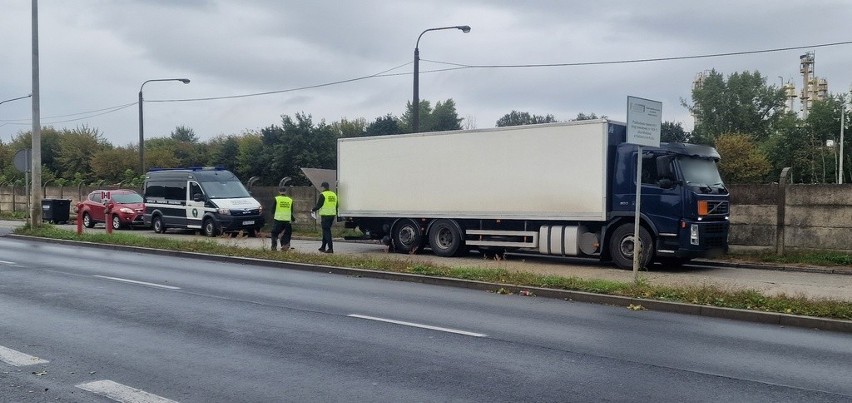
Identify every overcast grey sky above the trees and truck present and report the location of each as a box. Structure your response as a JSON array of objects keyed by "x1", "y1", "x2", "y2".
[{"x1": 0, "y1": 0, "x2": 852, "y2": 146}]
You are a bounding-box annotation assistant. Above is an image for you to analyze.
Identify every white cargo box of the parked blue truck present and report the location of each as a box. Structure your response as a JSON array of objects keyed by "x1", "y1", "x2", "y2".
[{"x1": 337, "y1": 120, "x2": 610, "y2": 221}]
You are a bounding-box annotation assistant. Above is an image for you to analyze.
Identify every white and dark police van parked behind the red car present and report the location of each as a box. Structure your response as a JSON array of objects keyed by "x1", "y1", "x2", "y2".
[{"x1": 142, "y1": 167, "x2": 264, "y2": 237}]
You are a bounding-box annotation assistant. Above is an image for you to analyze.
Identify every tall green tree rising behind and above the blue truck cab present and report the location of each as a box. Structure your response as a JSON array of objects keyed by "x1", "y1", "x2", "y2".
[{"x1": 682, "y1": 70, "x2": 785, "y2": 144}]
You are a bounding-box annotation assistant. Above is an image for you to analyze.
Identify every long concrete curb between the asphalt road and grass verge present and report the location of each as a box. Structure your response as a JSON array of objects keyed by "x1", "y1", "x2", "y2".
[{"x1": 7, "y1": 234, "x2": 852, "y2": 333}]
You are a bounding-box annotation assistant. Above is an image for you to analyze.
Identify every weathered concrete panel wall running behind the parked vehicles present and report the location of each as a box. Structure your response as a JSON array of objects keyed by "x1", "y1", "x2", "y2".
[{"x1": 0, "y1": 184, "x2": 852, "y2": 253}]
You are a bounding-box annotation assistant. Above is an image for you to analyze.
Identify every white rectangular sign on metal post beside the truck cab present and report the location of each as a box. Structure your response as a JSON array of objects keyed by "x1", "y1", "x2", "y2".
[{"x1": 627, "y1": 96, "x2": 663, "y2": 282}]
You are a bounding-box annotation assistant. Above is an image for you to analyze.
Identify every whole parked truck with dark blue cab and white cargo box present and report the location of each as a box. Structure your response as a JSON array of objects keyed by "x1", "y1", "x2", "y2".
[{"x1": 337, "y1": 119, "x2": 730, "y2": 268}]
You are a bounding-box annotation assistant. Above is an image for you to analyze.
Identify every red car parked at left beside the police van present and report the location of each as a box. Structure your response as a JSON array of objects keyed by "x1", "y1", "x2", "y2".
[{"x1": 77, "y1": 189, "x2": 145, "y2": 229}]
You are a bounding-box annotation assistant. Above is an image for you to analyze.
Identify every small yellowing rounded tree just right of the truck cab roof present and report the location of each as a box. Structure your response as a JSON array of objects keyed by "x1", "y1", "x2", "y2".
[{"x1": 716, "y1": 133, "x2": 771, "y2": 183}]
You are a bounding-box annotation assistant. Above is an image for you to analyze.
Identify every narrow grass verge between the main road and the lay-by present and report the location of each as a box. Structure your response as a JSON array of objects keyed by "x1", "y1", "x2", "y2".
[{"x1": 15, "y1": 224, "x2": 852, "y2": 320}]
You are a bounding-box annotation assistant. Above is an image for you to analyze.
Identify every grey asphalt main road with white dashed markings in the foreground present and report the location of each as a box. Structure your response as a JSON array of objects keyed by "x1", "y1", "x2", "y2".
[{"x1": 0, "y1": 238, "x2": 852, "y2": 402}]
